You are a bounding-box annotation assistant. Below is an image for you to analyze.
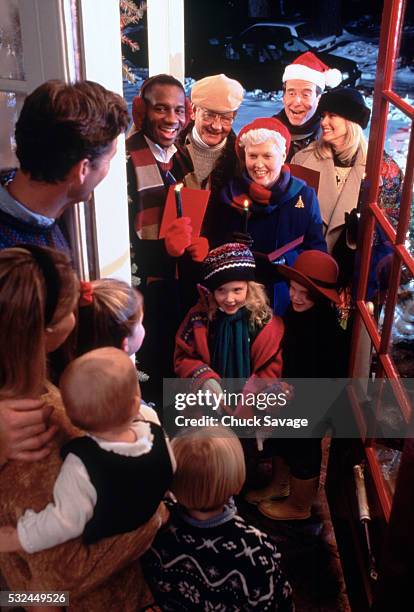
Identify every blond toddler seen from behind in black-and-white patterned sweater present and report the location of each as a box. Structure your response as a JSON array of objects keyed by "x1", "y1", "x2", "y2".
[{"x1": 143, "y1": 427, "x2": 294, "y2": 612}]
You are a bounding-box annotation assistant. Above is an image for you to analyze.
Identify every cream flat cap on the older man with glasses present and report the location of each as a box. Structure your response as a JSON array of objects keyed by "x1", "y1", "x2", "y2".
[{"x1": 191, "y1": 74, "x2": 244, "y2": 113}]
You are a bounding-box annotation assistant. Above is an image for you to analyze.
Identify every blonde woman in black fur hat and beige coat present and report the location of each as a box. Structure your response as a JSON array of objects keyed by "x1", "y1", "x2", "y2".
[{"x1": 292, "y1": 88, "x2": 402, "y2": 320}]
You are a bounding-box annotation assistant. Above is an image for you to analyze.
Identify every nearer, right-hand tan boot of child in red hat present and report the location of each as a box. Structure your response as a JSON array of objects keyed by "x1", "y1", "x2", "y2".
[{"x1": 258, "y1": 476, "x2": 319, "y2": 521}]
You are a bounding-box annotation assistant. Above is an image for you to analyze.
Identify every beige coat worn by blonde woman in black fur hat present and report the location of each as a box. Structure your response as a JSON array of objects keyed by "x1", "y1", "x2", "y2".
[{"x1": 292, "y1": 145, "x2": 365, "y2": 253}]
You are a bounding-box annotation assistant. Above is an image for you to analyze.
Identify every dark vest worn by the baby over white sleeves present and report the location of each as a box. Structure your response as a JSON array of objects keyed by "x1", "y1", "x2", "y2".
[{"x1": 61, "y1": 421, "x2": 173, "y2": 544}]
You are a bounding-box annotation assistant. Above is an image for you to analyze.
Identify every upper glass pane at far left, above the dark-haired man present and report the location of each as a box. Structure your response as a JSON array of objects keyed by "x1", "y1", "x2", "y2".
[{"x1": 0, "y1": 0, "x2": 25, "y2": 81}]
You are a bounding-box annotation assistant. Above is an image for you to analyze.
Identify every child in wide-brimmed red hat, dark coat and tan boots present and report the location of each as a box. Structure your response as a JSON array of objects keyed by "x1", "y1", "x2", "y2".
[{"x1": 247, "y1": 250, "x2": 346, "y2": 520}]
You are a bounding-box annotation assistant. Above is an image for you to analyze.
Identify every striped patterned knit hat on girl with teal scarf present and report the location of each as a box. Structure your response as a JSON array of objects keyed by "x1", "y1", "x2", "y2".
[{"x1": 203, "y1": 242, "x2": 256, "y2": 291}]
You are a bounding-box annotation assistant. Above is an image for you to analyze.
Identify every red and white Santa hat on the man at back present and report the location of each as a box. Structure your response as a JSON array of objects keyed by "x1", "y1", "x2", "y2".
[{"x1": 282, "y1": 51, "x2": 342, "y2": 90}]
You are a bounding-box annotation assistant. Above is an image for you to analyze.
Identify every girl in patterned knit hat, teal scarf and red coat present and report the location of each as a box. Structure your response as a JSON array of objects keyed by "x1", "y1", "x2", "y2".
[{"x1": 175, "y1": 243, "x2": 283, "y2": 404}]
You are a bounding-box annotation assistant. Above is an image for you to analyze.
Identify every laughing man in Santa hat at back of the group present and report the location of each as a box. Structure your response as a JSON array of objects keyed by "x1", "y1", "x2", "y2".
[{"x1": 274, "y1": 51, "x2": 342, "y2": 162}]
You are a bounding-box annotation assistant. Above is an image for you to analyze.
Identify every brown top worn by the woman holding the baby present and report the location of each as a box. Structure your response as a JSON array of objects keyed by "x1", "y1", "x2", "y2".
[{"x1": 0, "y1": 385, "x2": 160, "y2": 612}]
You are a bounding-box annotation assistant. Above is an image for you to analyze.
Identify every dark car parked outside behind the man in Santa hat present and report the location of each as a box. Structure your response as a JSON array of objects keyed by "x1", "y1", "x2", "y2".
[{"x1": 186, "y1": 24, "x2": 361, "y2": 91}]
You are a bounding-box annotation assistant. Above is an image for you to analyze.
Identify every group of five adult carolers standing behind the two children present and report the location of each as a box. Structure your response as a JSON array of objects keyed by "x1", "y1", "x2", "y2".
[{"x1": 127, "y1": 52, "x2": 402, "y2": 404}]
